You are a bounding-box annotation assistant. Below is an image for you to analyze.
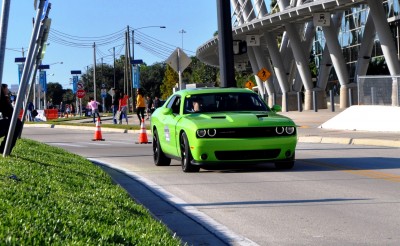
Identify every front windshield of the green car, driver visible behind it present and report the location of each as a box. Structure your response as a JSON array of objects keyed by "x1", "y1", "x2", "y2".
[{"x1": 184, "y1": 92, "x2": 270, "y2": 114}]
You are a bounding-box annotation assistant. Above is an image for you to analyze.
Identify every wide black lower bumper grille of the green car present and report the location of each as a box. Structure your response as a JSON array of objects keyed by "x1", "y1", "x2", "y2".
[{"x1": 215, "y1": 149, "x2": 281, "y2": 161}]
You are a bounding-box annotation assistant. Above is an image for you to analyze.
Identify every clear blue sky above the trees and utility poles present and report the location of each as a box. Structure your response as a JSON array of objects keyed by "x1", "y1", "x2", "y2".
[{"x1": 2, "y1": 0, "x2": 218, "y2": 89}]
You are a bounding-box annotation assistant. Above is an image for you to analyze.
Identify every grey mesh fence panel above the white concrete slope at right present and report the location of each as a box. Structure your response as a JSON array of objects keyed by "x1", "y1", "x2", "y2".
[{"x1": 357, "y1": 75, "x2": 400, "y2": 106}]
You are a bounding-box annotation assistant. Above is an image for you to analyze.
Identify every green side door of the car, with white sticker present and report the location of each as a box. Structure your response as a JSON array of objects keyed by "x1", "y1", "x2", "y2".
[{"x1": 162, "y1": 95, "x2": 182, "y2": 156}]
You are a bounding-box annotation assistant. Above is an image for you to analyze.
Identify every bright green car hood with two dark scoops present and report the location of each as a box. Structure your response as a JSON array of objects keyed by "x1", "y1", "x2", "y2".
[{"x1": 186, "y1": 112, "x2": 295, "y2": 128}]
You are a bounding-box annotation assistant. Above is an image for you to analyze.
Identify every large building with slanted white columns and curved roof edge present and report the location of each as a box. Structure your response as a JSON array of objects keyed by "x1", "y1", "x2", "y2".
[{"x1": 196, "y1": 0, "x2": 400, "y2": 111}]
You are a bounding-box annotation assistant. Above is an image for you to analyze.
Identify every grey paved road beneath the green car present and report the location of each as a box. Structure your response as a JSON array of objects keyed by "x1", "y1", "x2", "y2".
[{"x1": 23, "y1": 128, "x2": 400, "y2": 245}]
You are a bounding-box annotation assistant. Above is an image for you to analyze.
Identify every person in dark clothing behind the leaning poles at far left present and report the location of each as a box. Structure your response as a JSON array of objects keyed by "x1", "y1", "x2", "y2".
[{"x1": 0, "y1": 84, "x2": 22, "y2": 154}]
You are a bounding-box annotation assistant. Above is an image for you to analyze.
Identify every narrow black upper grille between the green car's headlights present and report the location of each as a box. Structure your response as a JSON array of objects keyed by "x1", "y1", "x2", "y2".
[{"x1": 206, "y1": 127, "x2": 296, "y2": 138}]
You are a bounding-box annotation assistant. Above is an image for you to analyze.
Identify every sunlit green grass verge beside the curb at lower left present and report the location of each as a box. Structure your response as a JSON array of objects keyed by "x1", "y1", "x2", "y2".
[{"x1": 0, "y1": 139, "x2": 180, "y2": 245}]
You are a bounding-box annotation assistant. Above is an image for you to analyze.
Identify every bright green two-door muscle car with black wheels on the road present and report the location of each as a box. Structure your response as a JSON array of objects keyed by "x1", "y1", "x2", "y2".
[{"x1": 151, "y1": 88, "x2": 297, "y2": 172}]
